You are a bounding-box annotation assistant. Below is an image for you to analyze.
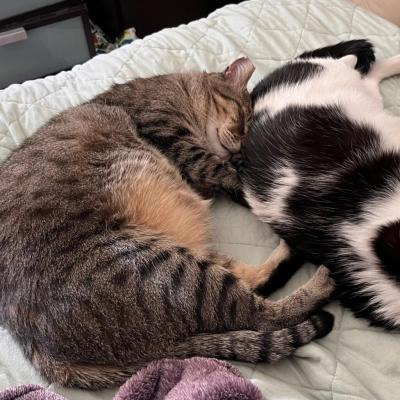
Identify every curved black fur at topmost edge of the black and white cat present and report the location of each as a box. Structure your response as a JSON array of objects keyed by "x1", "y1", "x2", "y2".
[{"x1": 298, "y1": 39, "x2": 375, "y2": 74}]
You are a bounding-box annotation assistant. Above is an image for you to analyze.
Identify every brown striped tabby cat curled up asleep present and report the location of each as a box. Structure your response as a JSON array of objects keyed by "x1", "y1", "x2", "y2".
[{"x1": 0, "y1": 59, "x2": 333, "y2": 388}]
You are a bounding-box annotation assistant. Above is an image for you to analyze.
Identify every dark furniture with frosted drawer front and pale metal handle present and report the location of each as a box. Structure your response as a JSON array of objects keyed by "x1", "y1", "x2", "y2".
[{"x1": 0, "y1": 0, "x2": 95, "y2": 88}]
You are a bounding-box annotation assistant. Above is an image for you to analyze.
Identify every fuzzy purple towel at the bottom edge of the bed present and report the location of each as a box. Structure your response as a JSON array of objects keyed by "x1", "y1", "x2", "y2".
[{"x1": 0, "y1": 357, "x2": 261, "y2": 400}]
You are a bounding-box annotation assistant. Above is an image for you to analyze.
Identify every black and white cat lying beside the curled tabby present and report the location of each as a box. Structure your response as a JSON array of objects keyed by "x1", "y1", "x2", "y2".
[{"x1": 241, "y1": 40, "x2": 400, "y2": 328}]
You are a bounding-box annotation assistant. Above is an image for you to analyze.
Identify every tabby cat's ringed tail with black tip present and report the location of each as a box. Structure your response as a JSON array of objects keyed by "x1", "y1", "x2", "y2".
[{"x1": 34, "y1": 311, "x2": 334, "y2": 389}]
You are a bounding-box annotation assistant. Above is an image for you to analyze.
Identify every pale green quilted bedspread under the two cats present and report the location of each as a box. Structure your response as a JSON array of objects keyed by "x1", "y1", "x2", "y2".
[{"x1": 0, "y1": 0, "x2": 400, "y2": 400}]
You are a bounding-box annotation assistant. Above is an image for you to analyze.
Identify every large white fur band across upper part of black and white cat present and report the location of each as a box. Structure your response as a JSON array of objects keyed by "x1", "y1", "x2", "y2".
[{"x1": 254, "y1": 58, "x2": 400, "y2": 151}]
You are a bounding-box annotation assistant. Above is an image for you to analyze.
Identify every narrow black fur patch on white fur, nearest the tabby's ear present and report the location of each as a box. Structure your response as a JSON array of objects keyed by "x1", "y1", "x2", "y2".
[{"x1": 251, "y1": 61, "x2": 324, "y2": 105}]
